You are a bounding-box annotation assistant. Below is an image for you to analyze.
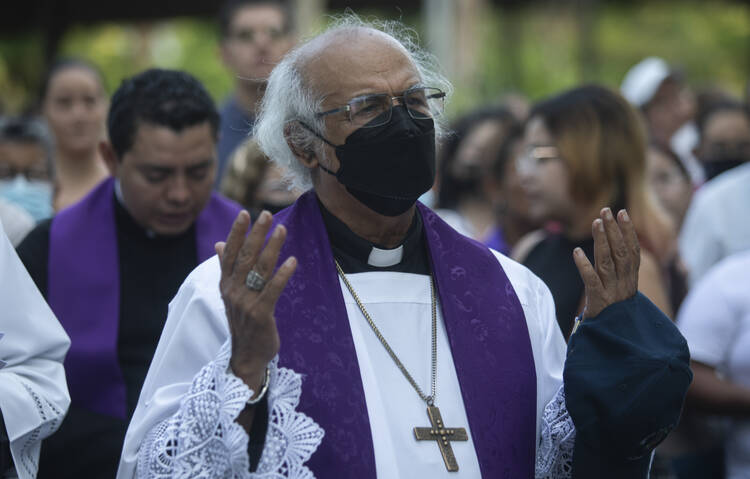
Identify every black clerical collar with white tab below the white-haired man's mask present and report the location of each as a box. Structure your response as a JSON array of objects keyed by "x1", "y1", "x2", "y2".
[{"x1": 318, "y1": 200, "x2": 430, "y2": 274}]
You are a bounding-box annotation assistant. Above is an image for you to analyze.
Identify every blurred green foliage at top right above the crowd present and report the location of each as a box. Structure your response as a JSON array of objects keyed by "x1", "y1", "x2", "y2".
[{"x1": 468, "y1": 1, "x2": 750, "y2": 113}]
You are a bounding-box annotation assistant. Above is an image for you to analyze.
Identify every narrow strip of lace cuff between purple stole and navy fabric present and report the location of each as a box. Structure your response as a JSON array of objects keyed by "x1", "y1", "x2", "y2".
[{"x1": 534, "y1": 385, "x2": 576, "y2": 479}]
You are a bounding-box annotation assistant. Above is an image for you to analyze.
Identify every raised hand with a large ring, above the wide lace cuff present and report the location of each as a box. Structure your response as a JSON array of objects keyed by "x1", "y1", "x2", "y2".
[{"x1": 216, "y1": 211, "x2": 297, "y2": 392}]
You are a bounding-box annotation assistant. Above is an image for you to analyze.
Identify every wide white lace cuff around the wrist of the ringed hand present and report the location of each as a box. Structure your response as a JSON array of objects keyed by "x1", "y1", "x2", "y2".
[{"x1": 137, "y1": 340, "x2": 323, "y2": 479}]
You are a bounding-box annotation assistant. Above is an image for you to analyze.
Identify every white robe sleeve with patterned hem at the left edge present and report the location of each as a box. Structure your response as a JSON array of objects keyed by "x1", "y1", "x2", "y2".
[{"x1": 0, "y1": 224, "x2": 70, "y2": 479}]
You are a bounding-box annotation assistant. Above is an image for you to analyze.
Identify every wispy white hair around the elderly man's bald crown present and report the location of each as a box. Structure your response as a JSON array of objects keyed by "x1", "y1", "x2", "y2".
[{"x1": 253, "y1": 12, "x2": 453, "y2": 190}]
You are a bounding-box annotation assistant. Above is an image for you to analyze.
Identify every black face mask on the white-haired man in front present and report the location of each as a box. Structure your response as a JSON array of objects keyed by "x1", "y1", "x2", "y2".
[{"x1": 303, "y1": 106, "x2": 435, "y2": 216}]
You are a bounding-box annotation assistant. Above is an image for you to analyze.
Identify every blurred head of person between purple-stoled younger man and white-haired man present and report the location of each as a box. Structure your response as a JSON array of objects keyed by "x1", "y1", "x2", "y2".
[{"x1": 221, "y1": 139, "x2": 302, "y2": 215}]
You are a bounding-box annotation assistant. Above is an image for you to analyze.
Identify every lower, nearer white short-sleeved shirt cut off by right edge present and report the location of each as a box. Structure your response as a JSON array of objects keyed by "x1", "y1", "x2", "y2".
[{"x1": 677, "y1": 251, "x2": 750, "y2": 479}]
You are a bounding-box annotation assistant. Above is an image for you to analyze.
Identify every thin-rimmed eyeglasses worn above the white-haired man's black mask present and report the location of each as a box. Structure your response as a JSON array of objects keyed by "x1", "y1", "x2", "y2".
[{"x1": 316, "y1": 87, "x2": 445, "y2": 128}]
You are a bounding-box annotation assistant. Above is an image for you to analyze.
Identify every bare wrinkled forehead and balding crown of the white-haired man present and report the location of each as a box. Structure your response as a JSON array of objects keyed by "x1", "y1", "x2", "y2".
[{"x1": 301, "y1": 27, "x2": 420, "y2": 102}]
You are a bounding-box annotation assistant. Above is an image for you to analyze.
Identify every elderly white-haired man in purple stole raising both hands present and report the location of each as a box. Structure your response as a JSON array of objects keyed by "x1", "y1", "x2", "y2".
[{"x1": 118, "y1": 15, "x2": 690, "y2": 478}]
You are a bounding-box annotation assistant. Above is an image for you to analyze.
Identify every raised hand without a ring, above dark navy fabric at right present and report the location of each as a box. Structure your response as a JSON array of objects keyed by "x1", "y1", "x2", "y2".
[{"x1": 573, "y1": 208, "x2": 641, "y2": 317}]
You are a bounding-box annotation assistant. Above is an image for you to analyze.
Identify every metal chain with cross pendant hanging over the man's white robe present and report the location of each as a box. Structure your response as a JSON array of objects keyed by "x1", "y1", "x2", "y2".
[{"x1": 335, "y1": 261, "x2": 469, "y2": 471}]
